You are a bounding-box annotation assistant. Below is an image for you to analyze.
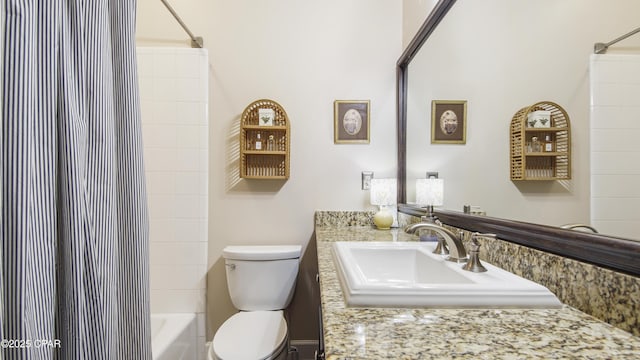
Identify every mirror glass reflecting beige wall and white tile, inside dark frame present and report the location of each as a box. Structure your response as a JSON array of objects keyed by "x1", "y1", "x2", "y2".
[{"x1": 405, "y1": 0, "x2": 640, "y2": 239}]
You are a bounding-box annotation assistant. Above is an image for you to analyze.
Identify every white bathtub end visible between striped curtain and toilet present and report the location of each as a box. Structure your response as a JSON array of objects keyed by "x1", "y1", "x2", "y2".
[{"x1": 151, "y1": 314, "x2": 197, "y2": 360}]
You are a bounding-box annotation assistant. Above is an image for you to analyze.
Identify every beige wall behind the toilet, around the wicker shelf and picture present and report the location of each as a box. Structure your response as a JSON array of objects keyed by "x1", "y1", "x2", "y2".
[{"x1": 137, "y1": 0, "x2": 402, "y2": 337}]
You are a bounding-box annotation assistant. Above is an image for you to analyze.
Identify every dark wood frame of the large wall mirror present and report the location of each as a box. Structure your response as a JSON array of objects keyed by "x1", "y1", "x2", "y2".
[{"x1": 396, "y1": 0, "x2": 640, "y2": 276}]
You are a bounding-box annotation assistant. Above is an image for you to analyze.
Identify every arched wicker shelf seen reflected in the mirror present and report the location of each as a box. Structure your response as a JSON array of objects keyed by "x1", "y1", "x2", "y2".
[{"x1": 510, "y1": 101, "x2": 571, "y2": 180}]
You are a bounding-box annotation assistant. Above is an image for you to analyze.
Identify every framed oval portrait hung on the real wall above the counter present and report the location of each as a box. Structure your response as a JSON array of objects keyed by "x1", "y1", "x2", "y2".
[{"x1": 333, "y1": 100, "x2": 370, "y2": 144}]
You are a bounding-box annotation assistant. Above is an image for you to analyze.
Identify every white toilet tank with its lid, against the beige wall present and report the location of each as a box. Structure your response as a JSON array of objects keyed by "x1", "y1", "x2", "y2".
[{"x1": 222, "y1": 245, "x2": 302, "y2": 311}]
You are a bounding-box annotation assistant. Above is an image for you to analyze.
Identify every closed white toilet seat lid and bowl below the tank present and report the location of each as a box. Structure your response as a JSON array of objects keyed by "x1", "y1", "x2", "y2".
[{"x1": 209, "y1": 311, "x2": 287, "y2": 360}]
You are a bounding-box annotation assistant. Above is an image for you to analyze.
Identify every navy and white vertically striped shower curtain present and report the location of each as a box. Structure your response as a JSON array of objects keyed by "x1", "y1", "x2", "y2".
[{"x1": 0, "y1": 0, "x2": 151, "y2": 360}]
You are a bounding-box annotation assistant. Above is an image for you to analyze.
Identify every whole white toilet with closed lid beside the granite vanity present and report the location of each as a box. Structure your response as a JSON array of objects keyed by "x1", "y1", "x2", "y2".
[{"x1": 208, "y1": 245, "x2": 302, "y2": 360}]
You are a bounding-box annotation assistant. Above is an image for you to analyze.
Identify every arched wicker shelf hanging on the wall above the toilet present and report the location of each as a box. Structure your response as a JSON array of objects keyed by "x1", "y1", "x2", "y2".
[{"x1": 240, "y1": 99, "x2": 290, "y2": 180}]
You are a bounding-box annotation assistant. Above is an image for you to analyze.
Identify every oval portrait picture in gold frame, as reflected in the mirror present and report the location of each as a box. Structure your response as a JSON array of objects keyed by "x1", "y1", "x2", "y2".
[{"x1": 431, "y1": 100, "x2": 467, "y2": 144}]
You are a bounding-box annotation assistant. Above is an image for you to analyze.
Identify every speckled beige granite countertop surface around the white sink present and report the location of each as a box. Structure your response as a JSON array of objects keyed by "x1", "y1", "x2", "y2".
[{"x1": 316, "y1": 226, "x2": 640, "y2": 360}]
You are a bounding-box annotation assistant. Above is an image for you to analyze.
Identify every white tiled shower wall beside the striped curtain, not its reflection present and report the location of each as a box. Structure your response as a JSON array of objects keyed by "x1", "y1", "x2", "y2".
[{"x1": 137, "y1": 47, "x2": 209, "y2": 358}]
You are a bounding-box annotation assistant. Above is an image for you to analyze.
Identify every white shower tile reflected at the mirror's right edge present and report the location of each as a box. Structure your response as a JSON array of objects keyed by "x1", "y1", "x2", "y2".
[{"x1": 590, "y1": 54, "x2": 640, "y2": 239}]
